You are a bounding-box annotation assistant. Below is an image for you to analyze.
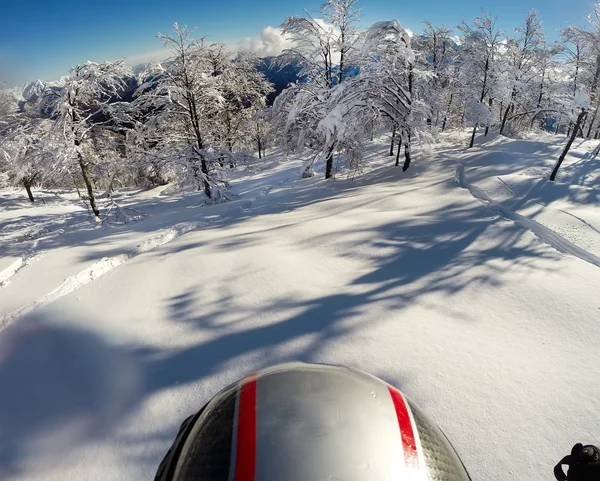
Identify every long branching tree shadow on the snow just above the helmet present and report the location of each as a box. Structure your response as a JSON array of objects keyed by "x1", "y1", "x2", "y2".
[{"x1": 134, "y1": 195, "x2": 552, "y2": 401}]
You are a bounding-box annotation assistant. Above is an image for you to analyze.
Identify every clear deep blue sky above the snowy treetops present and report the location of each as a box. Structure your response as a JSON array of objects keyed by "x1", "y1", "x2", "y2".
[{"x1": 0, "y1": 0, "x2": 593, "y2": 86}]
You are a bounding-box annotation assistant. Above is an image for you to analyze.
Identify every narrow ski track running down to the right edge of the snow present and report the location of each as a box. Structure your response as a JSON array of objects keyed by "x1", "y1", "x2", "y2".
[{"x1": 455, "y1": 164, "x2": 600, "y2": 267}]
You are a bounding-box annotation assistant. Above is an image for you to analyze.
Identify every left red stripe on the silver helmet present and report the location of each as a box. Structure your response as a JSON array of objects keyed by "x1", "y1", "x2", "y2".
[{"x1": 233, "y1": 374, "x2": 256, "y2": 481}]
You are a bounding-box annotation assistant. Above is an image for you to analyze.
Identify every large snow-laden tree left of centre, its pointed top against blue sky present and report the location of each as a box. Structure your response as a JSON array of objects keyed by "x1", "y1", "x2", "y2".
[{"x1": 130, "y1": 23, "x2": 271, "y2": 197}]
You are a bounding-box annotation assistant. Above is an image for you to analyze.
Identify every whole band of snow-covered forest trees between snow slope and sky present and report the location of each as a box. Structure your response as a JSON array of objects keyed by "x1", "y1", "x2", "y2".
[{"x1": 0, "y1": 0, "x2": 600, "y2": 220}]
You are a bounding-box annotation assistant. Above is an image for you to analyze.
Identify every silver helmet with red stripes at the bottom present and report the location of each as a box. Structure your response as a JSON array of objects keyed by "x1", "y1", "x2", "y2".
[{"x1": 156, "y1": 363, "x2": 470, "y2": 481}]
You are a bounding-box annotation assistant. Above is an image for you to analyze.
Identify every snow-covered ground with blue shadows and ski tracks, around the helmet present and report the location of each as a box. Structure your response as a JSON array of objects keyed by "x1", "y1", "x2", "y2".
[{"x1": 0, "y1": 129, "x2": 600, "y2": 480}]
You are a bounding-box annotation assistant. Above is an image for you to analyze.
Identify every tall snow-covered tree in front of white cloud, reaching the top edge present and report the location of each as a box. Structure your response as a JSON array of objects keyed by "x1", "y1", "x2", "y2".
[{"x1": 275, "y1": 0, "x2": 359, "y2": 178}]
